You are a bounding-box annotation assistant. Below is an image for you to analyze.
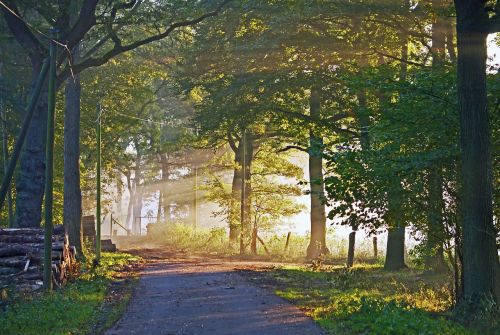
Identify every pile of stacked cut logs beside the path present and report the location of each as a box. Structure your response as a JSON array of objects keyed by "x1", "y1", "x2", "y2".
[{"x1": 0, "y1": 225, "x2": 76, "y2": 290}]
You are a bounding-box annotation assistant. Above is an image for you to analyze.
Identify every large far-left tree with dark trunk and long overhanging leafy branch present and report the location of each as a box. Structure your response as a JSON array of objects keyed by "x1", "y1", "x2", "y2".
[{"x1": 2, "y1": 0, "x2": 231, "y2": 227}]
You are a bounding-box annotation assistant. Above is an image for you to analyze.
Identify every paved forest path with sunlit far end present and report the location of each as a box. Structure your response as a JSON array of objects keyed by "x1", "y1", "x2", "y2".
[{"x1": 105, "y1": 248, "x2": 324, "y2": 335}]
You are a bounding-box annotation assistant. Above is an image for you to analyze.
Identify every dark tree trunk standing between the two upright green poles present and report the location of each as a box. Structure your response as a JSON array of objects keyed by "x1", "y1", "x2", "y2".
[{"x1": 63, "y1": 46, "x2": 84, "y2": 256}]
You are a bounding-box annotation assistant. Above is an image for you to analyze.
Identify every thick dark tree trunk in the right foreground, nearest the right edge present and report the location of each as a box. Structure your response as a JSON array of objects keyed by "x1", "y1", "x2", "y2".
[{"x1": 455, "y1": 0, "x2": 500, "y2": 303}]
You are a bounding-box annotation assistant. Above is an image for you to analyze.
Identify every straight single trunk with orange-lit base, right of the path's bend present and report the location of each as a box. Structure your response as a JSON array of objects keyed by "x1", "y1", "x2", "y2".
[{"x1": 307, "y1": 89, "x2": 329, "y2": 259}]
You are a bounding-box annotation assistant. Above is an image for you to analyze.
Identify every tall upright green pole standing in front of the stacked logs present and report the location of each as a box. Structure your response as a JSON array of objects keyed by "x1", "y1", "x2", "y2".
[{"x1": 43, "y1": 29, "x2": 57, "y2": 291}]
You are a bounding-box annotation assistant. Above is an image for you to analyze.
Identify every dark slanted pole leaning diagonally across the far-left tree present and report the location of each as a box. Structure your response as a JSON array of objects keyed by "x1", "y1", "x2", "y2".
[{"x1": 0, "y1": 58, "x2": 50, "y2": 210}]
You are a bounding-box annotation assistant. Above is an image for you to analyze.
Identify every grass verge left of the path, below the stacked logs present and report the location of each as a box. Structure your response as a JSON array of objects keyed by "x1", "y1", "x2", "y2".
[{"x1": 0, "y1": 253, "x2": 139, "y2": 335}]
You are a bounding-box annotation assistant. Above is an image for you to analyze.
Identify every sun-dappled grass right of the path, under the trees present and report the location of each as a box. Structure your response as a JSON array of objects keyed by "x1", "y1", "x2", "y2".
[{"x1": 246, "y1": 264, "x2": 474, "y2": 335}]
